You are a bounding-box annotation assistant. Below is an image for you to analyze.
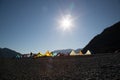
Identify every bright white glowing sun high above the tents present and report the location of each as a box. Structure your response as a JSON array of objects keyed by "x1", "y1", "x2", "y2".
[{"x1": 60, "y1": 15, "x2": 73, "y2": 31}]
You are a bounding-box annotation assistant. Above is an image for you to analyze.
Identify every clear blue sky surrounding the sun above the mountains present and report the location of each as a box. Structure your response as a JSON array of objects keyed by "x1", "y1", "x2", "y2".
[{"x1": 0, "y1": 0, "x2": 120, "y2": 53}]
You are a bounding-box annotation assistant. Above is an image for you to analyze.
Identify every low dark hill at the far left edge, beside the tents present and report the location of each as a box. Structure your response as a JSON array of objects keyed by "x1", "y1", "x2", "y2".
[{"x1": 0, "y1": 48, "x2": 21, "y2": 58}]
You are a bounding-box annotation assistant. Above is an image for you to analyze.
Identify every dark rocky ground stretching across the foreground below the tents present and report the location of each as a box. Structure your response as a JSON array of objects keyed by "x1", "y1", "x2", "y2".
[{"x1": 0, "y1": 53, "x2": 120, "y2": 80}]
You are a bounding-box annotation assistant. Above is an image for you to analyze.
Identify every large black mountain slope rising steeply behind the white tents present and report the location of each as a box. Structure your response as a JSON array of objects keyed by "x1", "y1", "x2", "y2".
[{"x1": 82, "y1": 22, "x2": 120, "y2": 54}]
